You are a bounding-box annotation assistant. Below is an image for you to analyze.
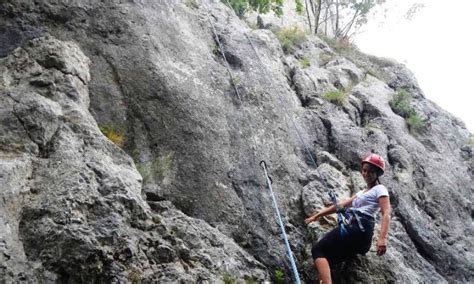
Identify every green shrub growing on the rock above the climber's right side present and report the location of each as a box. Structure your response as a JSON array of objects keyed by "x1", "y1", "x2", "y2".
[{"x1": 390, "y1": 89, "x2": 426, "y2": 132}]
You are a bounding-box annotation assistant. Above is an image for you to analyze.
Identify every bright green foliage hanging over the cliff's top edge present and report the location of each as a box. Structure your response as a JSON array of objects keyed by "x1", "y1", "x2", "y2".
[{"x1": 222, "y1": 0, "x2": 284, "y2": 18}]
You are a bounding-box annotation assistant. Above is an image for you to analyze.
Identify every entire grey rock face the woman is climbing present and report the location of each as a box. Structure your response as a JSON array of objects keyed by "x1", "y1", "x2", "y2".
[{"x1": 0, "y1": 0, "x2": 474, "y2": 283}]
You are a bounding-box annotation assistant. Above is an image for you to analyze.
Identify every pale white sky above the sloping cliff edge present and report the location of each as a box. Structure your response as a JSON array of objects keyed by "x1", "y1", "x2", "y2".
[{"x1": 354, "y1": 0, "x2": 474, "y2": 133}]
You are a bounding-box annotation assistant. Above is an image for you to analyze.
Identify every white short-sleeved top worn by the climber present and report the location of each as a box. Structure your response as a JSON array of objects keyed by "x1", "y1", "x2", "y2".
[{"x1": 352, "y1": 184, "x2": 388, "y2": 218}]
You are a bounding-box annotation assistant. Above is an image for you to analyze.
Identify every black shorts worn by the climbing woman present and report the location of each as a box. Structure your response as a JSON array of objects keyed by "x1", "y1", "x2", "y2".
[{"x1": 311, "y1": 214, "x2": 375, "y2": 265}]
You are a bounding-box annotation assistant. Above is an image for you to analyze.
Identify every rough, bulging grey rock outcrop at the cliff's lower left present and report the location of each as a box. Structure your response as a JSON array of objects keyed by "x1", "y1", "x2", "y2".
[{"x1": 0, "y1": 37, "x2": 269, "y2": 282}]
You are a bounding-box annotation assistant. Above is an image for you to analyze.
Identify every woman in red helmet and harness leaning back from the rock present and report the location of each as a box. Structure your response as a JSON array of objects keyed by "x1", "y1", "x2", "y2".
[{"x1": 305, "y1": 154, "x2": 391, "y2": 284}]
